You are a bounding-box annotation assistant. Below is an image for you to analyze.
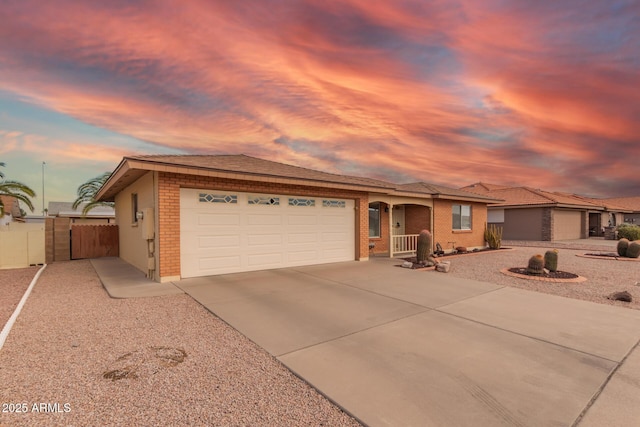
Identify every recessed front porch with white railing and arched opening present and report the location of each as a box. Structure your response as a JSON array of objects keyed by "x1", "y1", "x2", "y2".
[{"x1": 369, "y1": 201, "x2": 432, "y2": 258}]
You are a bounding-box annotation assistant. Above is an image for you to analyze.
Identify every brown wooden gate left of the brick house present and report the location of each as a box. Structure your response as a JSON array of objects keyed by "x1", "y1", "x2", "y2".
[{"x1": 71, "y1": 224, "x2": 119, "y2": 259}]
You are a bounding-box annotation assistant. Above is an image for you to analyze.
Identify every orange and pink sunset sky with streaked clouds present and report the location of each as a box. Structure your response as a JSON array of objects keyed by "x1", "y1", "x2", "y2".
[{"x1": 0, "y1": 0, "x2": 640, "y2": 213}]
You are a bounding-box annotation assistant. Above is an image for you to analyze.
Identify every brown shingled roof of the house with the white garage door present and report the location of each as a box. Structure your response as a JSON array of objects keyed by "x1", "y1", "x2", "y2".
[{"x1": 97, "y1": 154, "x2": 504, "y2": 203}]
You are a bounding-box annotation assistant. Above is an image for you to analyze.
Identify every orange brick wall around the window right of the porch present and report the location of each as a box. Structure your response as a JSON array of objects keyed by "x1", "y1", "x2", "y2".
[{"x1": 431, "y1": 199, "x2": 487, "y2": 251}]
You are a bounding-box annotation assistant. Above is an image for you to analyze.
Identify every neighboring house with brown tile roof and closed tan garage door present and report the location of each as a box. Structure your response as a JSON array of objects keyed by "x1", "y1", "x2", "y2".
[{"x1": 462, "y1": 182, "x2": 606, "y2": 241}]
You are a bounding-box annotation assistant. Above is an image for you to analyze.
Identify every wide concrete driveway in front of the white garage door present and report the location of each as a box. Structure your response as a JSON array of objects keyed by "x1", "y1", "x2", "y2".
[{"x1": 175, "y1": 259, "x2": 640, "y2": 426}]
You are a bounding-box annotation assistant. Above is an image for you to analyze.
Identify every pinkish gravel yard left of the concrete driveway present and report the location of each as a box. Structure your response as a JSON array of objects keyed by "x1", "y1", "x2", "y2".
[{"x1": 0, "y1": 261, "x2": 359, "y2": 426}]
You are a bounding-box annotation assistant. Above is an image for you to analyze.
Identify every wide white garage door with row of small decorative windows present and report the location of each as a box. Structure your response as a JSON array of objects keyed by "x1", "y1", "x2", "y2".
[{"x1": 180, "y1": 189, "x2": 355, "y2": 277}]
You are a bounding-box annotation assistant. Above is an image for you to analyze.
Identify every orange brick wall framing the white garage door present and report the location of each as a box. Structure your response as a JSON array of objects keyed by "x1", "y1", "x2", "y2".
[{"x1": 158, "y1": 172, "x2": 370, "y2": 280}]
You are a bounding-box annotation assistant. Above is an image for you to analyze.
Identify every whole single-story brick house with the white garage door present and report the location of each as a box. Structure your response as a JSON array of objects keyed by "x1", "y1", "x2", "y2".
[{"x1": 97, "y1": 155, "x2": 498, "y2": 282}]
